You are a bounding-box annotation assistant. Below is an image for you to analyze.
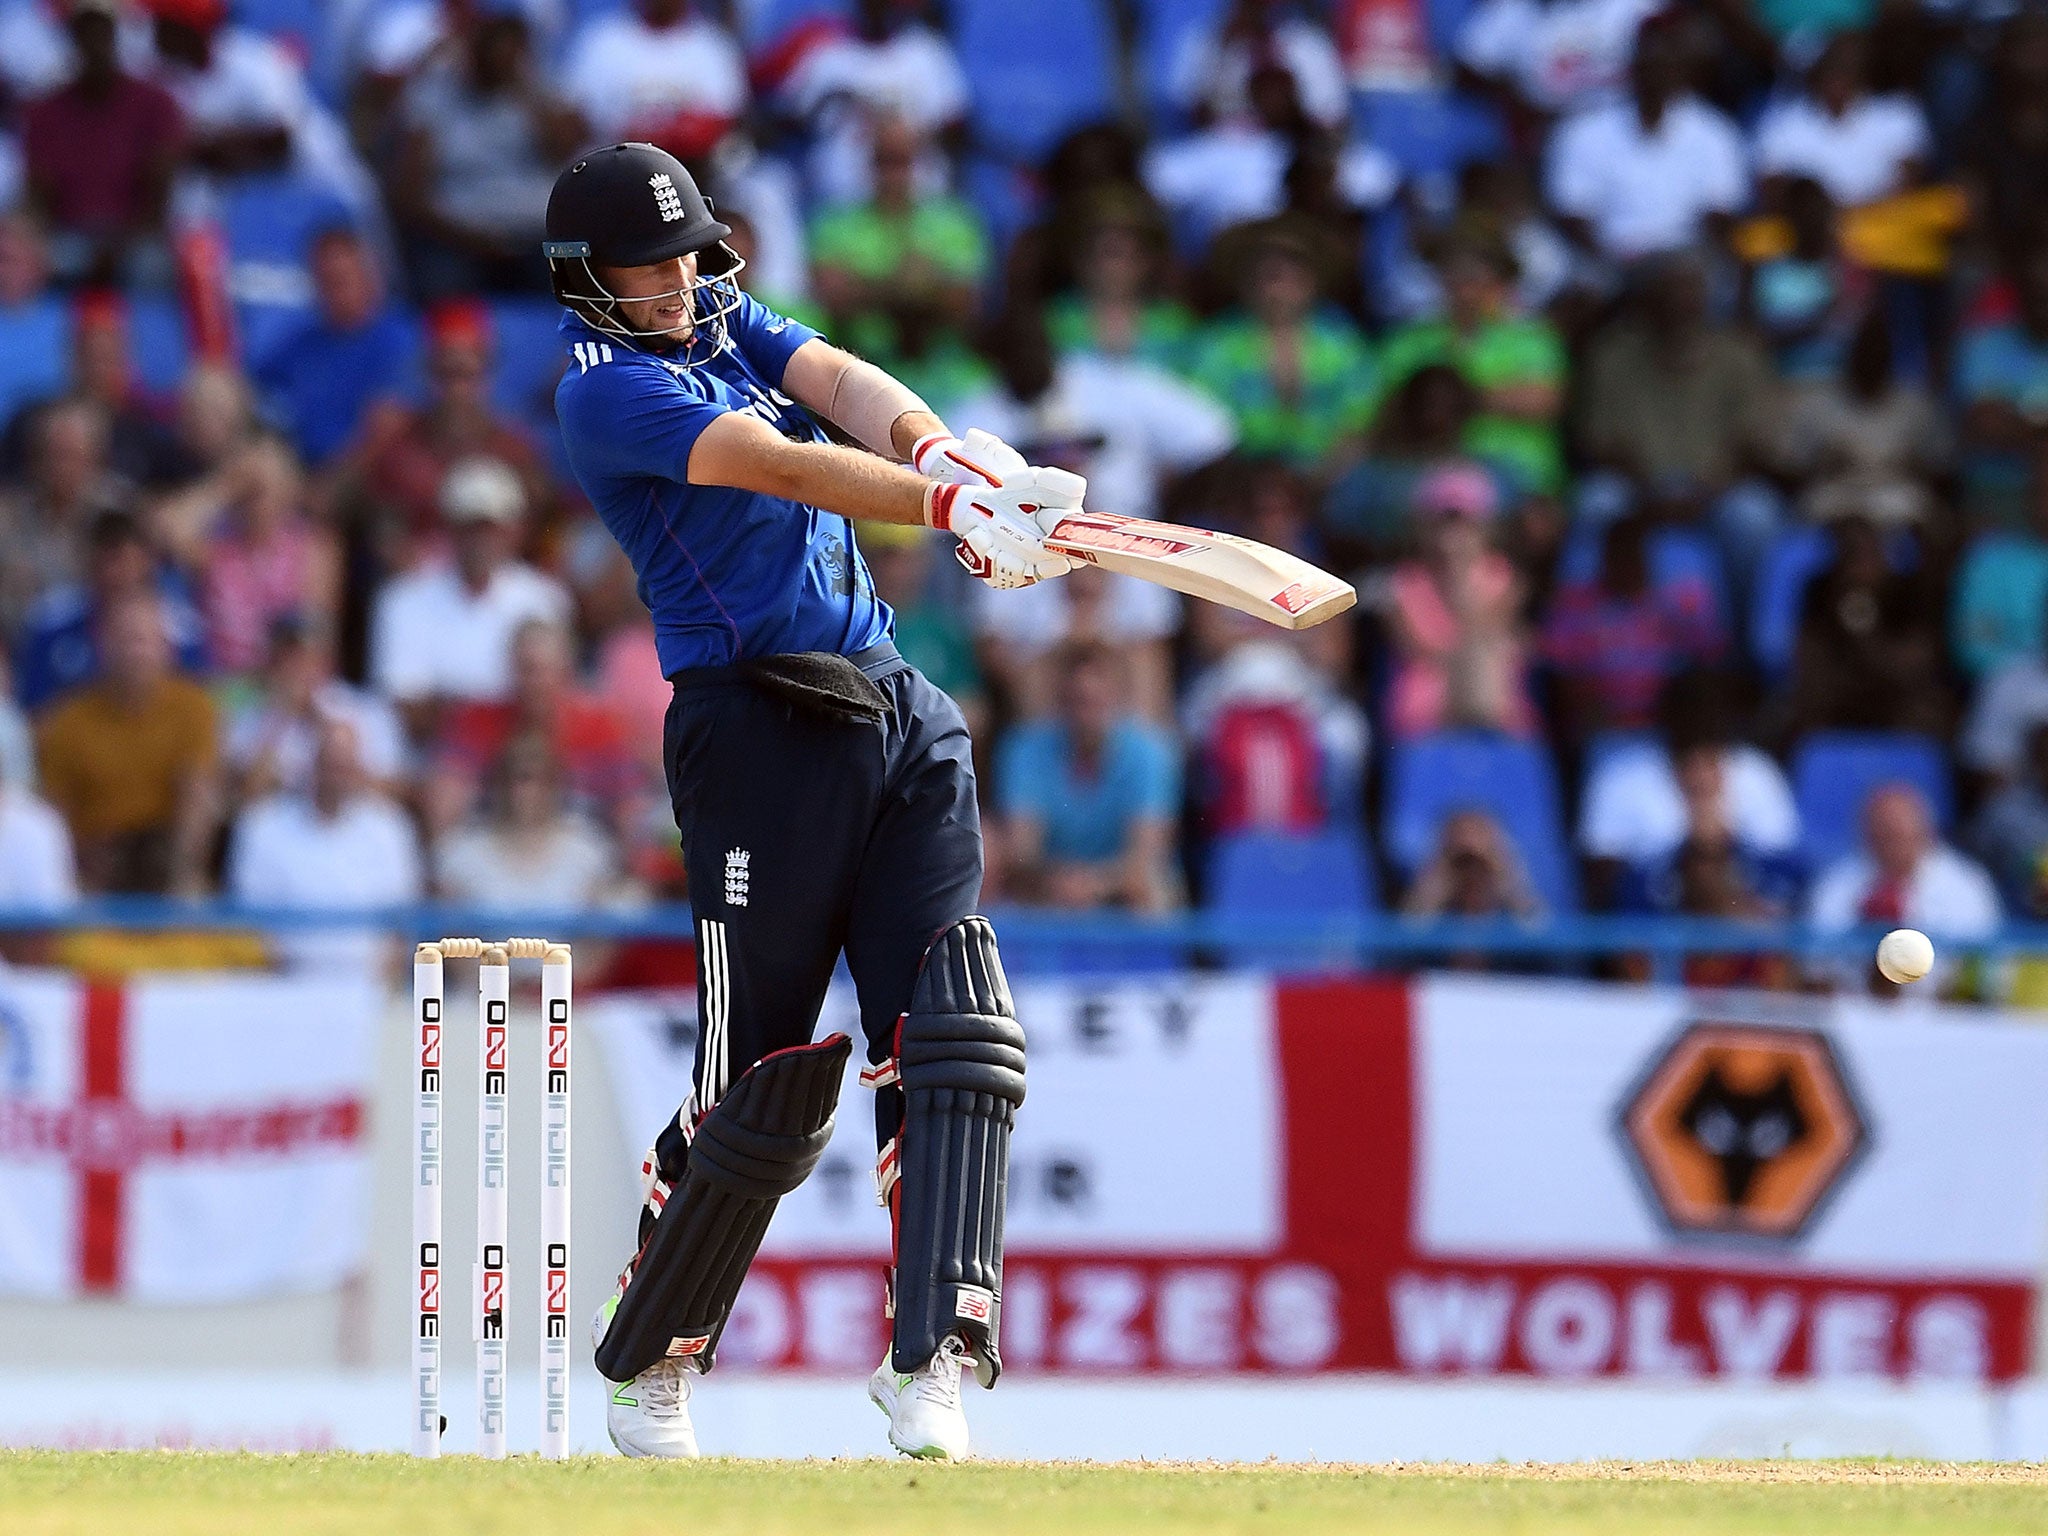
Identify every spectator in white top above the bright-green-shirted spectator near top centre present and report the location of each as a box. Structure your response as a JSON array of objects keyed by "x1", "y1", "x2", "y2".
[{"x1": 786, "y1": 0, "x2": 969, "y2": 209}]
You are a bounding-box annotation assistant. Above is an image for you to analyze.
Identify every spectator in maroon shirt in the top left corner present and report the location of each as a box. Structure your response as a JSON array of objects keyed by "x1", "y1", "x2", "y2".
[{"x1": 23, "y1": 0, "x2": 184, "y2": 283}]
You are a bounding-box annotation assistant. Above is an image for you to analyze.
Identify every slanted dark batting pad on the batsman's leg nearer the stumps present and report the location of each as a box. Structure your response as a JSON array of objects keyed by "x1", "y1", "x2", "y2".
[{"x1": 598, "y1": 1034, "x2": 852, "y2": 1380}]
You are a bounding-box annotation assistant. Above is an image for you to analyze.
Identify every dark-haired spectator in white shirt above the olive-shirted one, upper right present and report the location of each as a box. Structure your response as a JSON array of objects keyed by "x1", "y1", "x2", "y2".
[{"x1": 1546, "y1": 16, "x2": 1749, "y2": 260}]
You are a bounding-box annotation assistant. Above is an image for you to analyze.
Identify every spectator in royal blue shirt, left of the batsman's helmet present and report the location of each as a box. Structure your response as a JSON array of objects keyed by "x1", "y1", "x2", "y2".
[{"x1": 258, "y1": 227, "x2": 420, "y2": 471}]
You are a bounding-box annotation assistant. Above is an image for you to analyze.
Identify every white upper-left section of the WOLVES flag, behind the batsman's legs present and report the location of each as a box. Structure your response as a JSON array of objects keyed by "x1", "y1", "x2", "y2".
[{"x1": 580, "y1": 977, "x2": 1282, "y2": 1260}]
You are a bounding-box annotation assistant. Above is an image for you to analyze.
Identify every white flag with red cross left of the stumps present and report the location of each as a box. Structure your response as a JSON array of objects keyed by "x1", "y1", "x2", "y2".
[{"x1": 0, "y1": 971, "x2": 381, "y2": 1303}]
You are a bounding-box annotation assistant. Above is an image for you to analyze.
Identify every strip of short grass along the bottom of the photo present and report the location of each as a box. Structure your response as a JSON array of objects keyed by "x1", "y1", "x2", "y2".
[{"x1": 0, "y1": 1452, "x2": 2048, "y2": 1536}]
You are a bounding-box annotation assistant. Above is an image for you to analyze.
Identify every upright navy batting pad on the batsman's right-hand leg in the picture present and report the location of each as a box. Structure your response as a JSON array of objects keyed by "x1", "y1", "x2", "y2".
[{"x1": 891, "y1": 918, "x2": 1024, "y2": 1386}]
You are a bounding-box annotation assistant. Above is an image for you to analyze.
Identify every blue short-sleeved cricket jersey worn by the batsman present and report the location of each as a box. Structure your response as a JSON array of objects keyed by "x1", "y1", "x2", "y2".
[{"x1": 555, "y1": 297, "x2": 895, "y2": 676}]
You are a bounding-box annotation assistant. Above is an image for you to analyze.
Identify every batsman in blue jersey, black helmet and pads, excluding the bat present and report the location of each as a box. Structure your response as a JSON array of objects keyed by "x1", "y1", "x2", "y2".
[{"x1": 545, "y1": 143, "x2": 1085, "y2": 1456}]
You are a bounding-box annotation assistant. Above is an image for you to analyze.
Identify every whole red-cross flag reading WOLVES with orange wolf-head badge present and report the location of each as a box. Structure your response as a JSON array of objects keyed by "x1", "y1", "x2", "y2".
[{"x1": 586, "y1": 977, "x2": 2048, "y2": 1382}]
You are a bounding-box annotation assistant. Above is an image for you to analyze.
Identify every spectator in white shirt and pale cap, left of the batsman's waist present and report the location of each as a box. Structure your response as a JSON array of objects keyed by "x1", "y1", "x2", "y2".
[{"x1": 371, "y1": 459, "x2": 569, "y2": 741}]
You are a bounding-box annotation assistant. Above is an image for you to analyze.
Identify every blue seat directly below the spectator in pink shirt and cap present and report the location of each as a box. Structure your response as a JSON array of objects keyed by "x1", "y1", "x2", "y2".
[{"x1": 1380, "y1": 731, "x2": 1579, "y2": 911}]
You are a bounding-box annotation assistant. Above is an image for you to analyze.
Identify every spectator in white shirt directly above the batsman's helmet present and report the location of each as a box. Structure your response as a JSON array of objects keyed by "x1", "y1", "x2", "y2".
[{"x1": 561, "y1": 0, "x2": 748, "y2": 160}]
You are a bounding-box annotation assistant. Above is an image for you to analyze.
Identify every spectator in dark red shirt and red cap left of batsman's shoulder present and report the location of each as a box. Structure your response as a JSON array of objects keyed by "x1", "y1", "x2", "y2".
[{"x1": 342, "y1": 299, "x2": 553, "y2": 569}]
